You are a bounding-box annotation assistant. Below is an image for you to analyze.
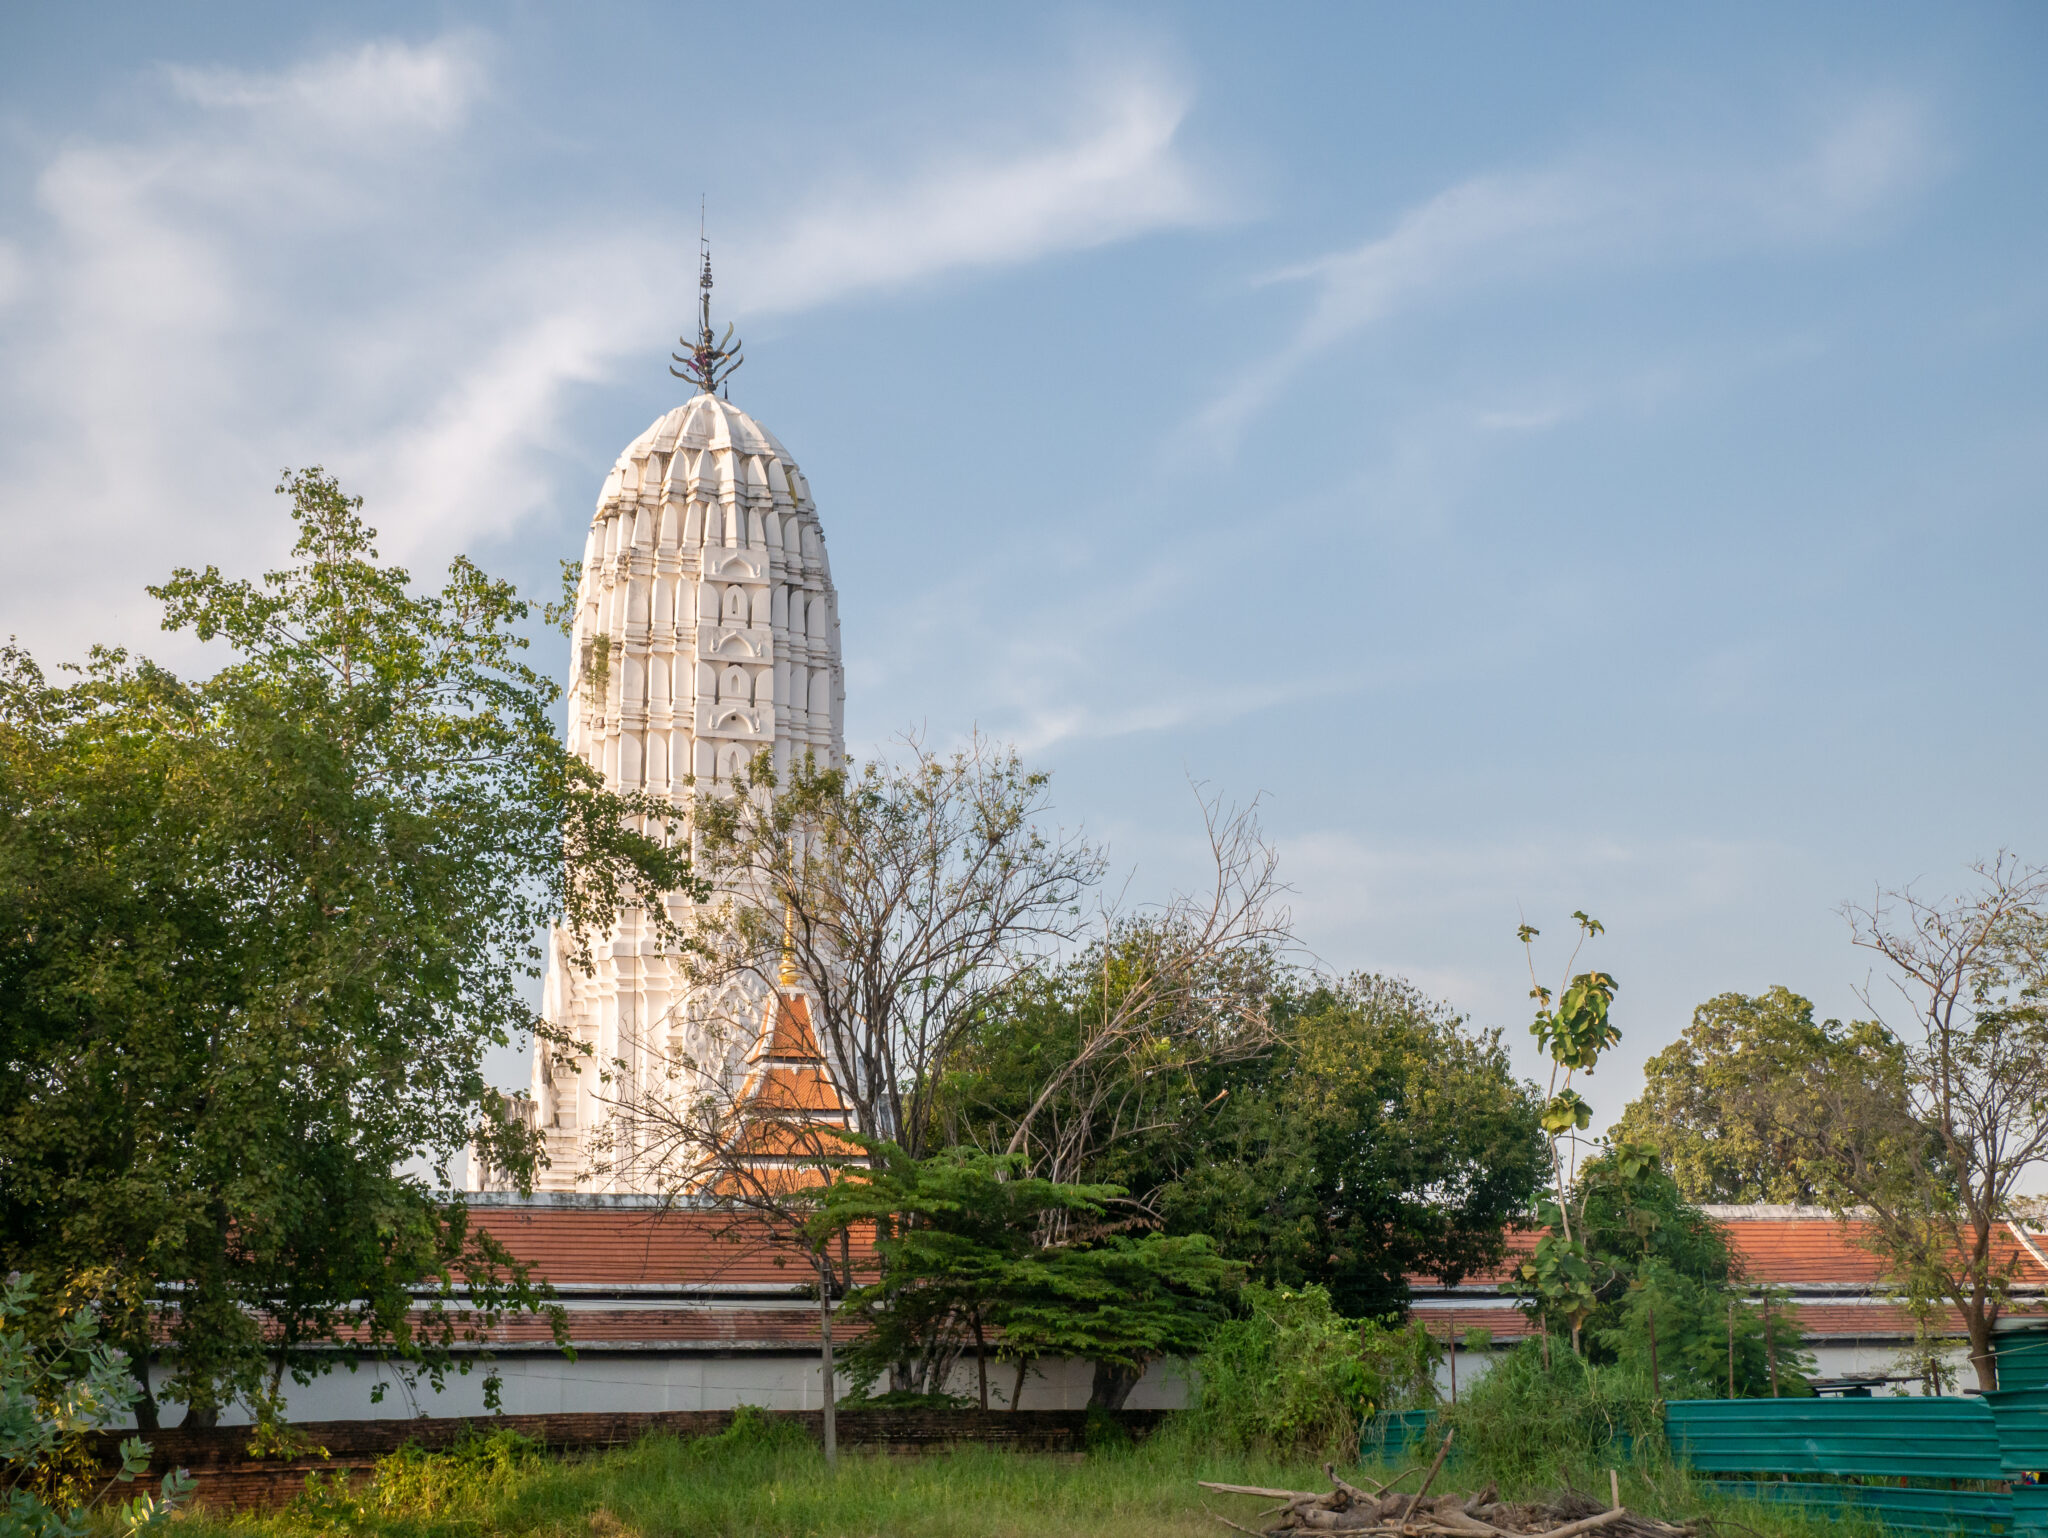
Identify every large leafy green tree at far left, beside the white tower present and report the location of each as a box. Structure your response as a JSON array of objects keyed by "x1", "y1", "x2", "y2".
[{"x1": 0, "y1": 471, "x2": 690, "y2": 1427}]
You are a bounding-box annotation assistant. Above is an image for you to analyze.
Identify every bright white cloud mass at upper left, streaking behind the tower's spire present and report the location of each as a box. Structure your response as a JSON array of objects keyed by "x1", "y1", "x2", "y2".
[{"x1": 0, "y1": 33, "x2": 1217, "y2": 651}]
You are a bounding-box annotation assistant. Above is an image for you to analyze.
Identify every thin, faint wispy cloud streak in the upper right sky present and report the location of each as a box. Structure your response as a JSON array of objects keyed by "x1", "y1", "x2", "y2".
[{"x1": 1196, "y1": 94, "x2": 1935, "y2": 448}]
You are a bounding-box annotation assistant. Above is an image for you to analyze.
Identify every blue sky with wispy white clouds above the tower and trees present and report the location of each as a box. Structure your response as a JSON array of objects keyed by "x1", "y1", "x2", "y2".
[{"x1": 0, "y1": 4, "x2": 2048, "y2": 1116}]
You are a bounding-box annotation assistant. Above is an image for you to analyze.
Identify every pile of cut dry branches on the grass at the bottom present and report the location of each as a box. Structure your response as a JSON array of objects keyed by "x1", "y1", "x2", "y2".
[{"x1": 1200, "y1": 1436, "x2": 1702, "y2": 1538}]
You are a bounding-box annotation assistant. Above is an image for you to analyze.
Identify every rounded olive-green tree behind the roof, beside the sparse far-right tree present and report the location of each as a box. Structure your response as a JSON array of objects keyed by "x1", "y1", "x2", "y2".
[{"x1": 1610, "y1": 987, "x2": 1896, "y2": 1204}]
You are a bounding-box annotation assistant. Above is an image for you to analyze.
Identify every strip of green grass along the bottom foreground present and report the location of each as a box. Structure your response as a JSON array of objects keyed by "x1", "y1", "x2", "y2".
[{"x1": 178, "y1": 1432, "x2": 1884, "y2": 1538}]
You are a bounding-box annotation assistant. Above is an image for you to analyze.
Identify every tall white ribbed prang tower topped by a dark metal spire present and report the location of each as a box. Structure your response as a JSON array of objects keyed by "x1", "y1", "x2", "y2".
[{"x1": 532, "y1": 250, "x2": 846, "y2": 1192}]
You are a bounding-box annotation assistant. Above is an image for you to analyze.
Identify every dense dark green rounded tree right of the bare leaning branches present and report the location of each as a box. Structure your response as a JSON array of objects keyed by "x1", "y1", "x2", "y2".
[{"x1": 1146, "y1": 975, "x2": 1544, "y2": 1317}]
